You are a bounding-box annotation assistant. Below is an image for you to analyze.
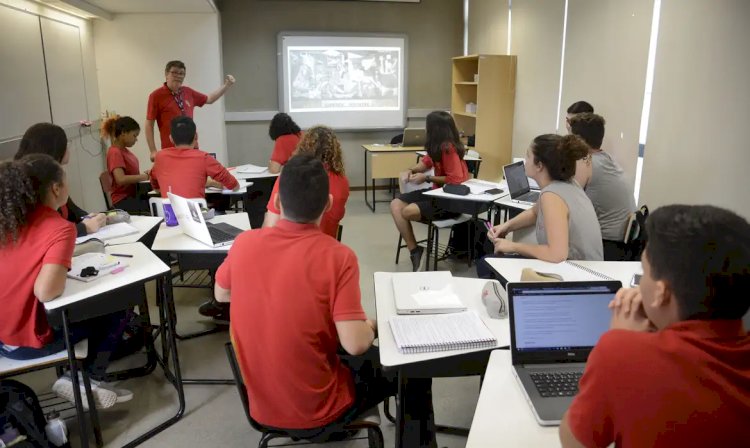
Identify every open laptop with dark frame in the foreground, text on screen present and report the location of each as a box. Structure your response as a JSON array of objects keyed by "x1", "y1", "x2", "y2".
[{"x1": 507, "y1": 281, "x2": 622, "y2": 426}]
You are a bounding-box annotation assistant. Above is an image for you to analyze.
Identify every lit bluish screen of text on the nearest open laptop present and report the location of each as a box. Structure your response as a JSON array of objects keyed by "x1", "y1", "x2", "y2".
[{"x1": 513, "y1": 287, "x2": 615, "y2": 351}]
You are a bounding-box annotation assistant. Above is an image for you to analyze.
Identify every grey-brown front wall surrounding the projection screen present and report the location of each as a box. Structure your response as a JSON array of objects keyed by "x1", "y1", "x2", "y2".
[{"x1": 220, "y1": 0, "x2": 463, "y2": 187}]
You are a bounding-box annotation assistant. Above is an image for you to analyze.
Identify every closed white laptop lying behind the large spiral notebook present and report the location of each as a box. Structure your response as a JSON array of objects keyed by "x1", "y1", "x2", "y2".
[{"x1": 392, "y1": 271, "x2": 466, "y2": 314}]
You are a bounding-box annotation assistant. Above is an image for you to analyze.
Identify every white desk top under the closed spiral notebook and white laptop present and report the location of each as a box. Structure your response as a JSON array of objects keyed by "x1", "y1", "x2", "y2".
[{"x1": 374, "y1": 272, "x2": 510, "y2": 367}]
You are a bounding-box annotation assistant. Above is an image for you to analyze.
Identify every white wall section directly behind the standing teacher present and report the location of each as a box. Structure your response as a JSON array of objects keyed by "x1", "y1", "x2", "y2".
[{"x1": 94, "y1": 14, "x2": 226, "y2": 168}]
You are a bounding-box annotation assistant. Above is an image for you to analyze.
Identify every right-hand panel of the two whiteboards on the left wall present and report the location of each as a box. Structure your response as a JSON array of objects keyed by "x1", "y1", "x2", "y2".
[{"x1": 40, "y1": 17, "x2": 89, "y2": 126}]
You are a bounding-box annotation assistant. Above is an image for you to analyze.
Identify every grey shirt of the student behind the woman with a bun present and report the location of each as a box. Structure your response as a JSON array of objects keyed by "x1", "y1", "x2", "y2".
[{"x1": 586, "y1": 151, "x2": 635, "y2": 241}]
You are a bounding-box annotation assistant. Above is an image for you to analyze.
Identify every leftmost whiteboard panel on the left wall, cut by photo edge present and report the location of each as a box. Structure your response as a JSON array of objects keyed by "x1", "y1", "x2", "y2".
[{"x1": 0, "y1": 6, "x2": 52, "y2": 139}]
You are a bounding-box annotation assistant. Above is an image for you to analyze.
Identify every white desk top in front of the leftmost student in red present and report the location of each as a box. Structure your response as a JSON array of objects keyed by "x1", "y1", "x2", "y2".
[{"x1": 44, "y1": 243, "x2": 169, "y2": 311}]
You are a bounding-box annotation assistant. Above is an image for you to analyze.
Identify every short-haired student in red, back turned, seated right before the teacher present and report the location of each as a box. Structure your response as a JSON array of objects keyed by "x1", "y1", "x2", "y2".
[{"x1": 151, "y1": 117, "x2": 240, "y2": 198}]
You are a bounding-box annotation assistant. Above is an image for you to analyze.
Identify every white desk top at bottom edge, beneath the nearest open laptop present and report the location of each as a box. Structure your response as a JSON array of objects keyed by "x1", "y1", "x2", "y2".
[{"x1": 466, "y1": 350, "x2": 560, "y2": 448}]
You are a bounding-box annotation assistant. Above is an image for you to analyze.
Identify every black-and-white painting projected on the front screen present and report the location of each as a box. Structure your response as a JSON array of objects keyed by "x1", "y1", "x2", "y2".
[{"x1": 288, "y1": 46, "x2": 401, "y2": 112}]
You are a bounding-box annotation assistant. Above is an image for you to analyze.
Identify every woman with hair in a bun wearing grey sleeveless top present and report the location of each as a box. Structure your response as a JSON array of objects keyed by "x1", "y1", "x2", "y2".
[{"x1": 477, "y1": 134, "x2": 602, "y2": 278}]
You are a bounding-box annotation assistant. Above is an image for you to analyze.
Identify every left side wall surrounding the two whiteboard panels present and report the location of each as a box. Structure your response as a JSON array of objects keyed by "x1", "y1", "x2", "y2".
[{"x1": 0, "y1": 0, "x2": 104, "y2": 211}]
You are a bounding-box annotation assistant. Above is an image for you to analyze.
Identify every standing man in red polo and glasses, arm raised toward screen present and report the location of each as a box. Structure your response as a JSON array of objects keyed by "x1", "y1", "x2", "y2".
[{"x1": 146, "y1": 61, "x2": 234, "y2": 161}]
